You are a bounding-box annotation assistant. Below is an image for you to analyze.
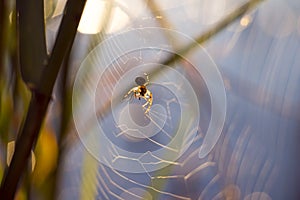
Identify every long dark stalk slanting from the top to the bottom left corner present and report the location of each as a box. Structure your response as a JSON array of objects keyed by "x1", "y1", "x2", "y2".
[{"x1": 0, "y1": 0, "x2": 85, "y2": 200}]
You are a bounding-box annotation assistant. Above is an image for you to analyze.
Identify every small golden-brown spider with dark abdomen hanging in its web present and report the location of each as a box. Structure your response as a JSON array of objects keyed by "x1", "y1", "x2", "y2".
[{"x1": 124, "y1": 73, "x2": 153, "y2": 114}]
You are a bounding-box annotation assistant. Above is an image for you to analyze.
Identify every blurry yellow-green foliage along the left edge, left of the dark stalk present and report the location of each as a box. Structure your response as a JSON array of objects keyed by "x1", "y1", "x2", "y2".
[{"x1": 0, "y1": 1, "x2": 30, "y2": 150}]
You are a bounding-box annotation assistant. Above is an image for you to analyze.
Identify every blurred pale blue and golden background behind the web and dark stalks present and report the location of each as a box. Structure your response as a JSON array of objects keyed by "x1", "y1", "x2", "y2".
[{"x1": 0, "y1": 0, "x2": 300, "y2": 200}]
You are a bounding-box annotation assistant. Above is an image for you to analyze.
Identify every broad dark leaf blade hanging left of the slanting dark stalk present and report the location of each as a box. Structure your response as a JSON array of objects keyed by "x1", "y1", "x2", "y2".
[{"x1": 17, "y1": 0, "x2": 47, "y2": 88}]
